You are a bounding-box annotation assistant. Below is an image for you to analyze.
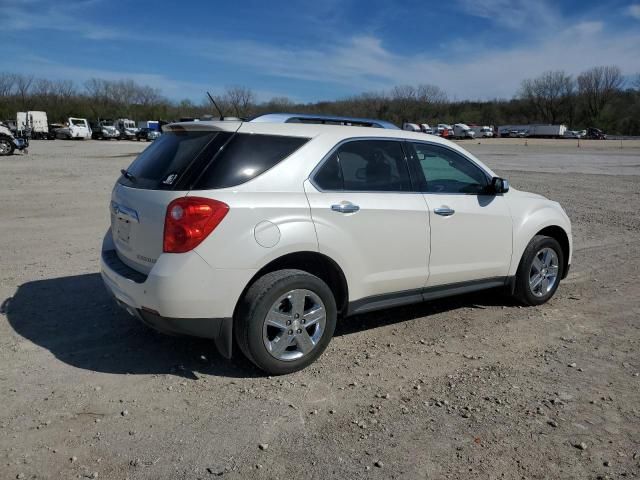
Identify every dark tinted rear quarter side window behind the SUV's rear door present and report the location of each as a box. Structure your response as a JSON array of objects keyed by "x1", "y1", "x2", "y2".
[{"x1": 193, "y1": 133, "x2": 309, "y2": 190}]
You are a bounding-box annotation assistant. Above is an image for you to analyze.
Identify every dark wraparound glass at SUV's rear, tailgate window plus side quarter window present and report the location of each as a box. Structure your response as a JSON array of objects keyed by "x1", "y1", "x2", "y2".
[{"x1": 119, "y1": 130, "x2": 309, "y2": 190}]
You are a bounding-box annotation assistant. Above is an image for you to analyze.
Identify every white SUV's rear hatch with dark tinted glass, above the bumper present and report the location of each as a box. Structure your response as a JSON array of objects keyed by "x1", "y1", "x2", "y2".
[{"x1": 111, "y1": 122, "x2": 240, "y2": 274}]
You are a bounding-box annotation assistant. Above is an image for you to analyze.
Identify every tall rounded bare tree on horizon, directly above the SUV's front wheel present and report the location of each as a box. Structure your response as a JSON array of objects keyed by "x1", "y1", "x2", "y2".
[{"x1": 520, "y1": 70, "x2": 575, "y2": 123}]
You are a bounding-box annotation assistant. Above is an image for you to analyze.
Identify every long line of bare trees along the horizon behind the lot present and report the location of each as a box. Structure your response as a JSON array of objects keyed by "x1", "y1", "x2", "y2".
[{"x1": 0, "y1": 66, "x2": 640, "y2": 135}]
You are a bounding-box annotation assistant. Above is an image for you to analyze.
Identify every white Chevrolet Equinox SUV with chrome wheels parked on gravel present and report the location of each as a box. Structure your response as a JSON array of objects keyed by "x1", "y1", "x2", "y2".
[{"x1": 101, "y1": 121, "x2": 572, "y2": 374}]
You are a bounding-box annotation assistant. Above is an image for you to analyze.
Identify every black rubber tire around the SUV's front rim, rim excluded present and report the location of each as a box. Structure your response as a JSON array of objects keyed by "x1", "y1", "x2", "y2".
[{"x1": 514, "y1": 235, "x2": 564, "y2": 306}]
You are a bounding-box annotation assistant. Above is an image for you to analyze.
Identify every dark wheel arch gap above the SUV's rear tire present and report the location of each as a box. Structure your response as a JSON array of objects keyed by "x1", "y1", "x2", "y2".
[{"x1": 234, "y1": 251, "x2": 349, "y2": 317}]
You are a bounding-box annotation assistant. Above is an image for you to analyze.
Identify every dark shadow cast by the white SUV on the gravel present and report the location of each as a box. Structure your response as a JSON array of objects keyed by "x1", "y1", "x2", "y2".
[{"x1": 0, "y1": 273, "x2": 516, "y2": 379}]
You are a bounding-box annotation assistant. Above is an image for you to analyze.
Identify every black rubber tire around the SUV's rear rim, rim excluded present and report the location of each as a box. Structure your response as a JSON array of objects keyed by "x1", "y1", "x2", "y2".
[{"x1": 234, "y1": 269, "x2": 337, "y2": 375}]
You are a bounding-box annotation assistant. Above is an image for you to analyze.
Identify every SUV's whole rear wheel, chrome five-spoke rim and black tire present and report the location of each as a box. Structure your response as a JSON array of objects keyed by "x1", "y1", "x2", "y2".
[{"x1": 235, "y1": 270, "x2": 337, "y2": 375}]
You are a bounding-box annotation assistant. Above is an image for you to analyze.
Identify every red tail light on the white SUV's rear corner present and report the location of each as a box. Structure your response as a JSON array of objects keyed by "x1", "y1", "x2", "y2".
[{"x1": 162, "y1": 197, "x2": 229, "y2": 253}]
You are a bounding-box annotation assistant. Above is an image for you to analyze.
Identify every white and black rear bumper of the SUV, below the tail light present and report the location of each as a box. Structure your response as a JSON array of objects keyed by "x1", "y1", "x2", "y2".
[{"x1": 100, "y1": 230, "x2": 255, "y2": 357}]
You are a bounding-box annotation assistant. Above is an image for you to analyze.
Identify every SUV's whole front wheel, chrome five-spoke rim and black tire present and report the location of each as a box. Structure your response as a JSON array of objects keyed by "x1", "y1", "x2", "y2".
[{"x1": 514, "y1": 235, "x2": 564, "y2": 305}]
